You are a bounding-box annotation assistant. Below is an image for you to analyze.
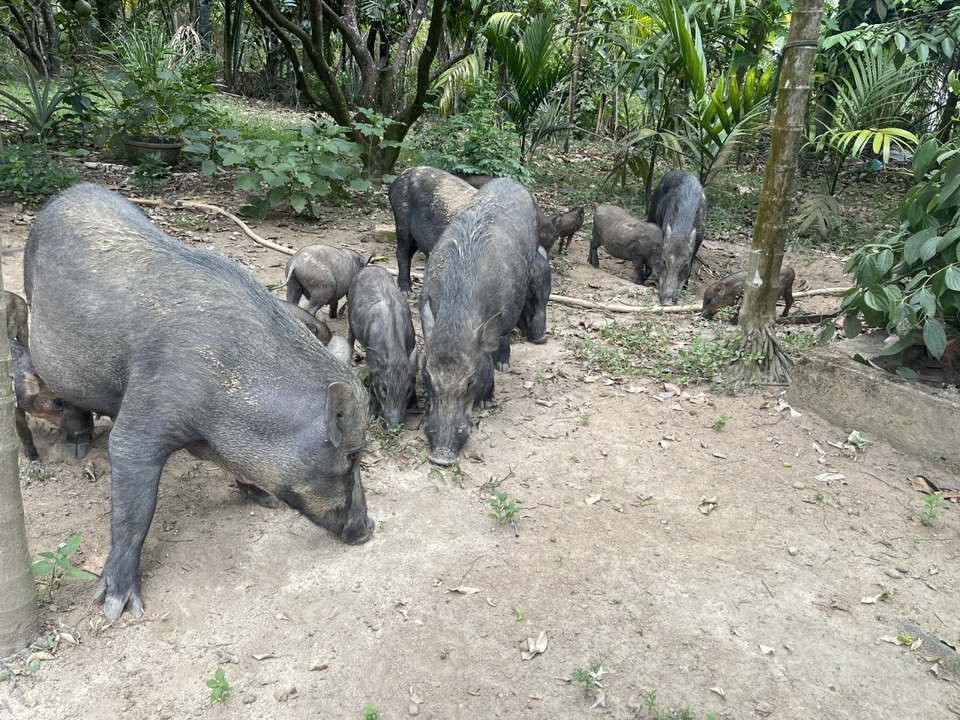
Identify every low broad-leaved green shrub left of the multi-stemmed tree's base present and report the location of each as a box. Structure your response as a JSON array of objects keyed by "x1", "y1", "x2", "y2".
[{"x1": 197, "y1": 118, "x2": 373, "y2": 217}]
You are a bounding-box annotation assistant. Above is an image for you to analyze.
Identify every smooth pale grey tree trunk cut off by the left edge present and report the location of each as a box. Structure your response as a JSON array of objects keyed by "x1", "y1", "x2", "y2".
[{"x1": 0, "y1": 268, "x2": 37, "y2": 657}]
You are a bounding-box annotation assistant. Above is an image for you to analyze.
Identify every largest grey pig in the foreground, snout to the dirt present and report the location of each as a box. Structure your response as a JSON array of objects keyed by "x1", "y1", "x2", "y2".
[{"x1": 24, "y1": 184, "x2": 374, "y2": 620}]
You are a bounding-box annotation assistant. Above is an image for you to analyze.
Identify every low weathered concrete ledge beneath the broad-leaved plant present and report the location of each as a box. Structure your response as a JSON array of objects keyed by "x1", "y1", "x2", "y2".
[{"x1": 787, "y1": 335, "x2": 960, "y2": 473}]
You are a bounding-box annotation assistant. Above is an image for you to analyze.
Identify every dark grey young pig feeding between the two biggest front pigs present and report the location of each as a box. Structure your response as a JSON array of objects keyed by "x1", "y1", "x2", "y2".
[{"x1": 347, "y1": 265, "x2": 417, "y2": 426}]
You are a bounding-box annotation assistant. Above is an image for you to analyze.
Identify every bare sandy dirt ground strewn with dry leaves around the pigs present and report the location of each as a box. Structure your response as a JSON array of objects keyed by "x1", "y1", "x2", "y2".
[{"x1": 0, "y1": 165, "x2": 960, "y2": 720}]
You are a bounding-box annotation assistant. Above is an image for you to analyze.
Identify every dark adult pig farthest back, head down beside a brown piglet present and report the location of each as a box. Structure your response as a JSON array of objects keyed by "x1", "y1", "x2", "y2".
[{"x1": 647, "y1": 170, "x2": 707, "y2": 305}]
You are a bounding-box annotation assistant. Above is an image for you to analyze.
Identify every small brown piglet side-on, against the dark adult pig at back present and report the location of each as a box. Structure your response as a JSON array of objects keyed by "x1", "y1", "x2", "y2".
[{"x1": 587, "y1": 205, "x2": 663, "y2": 285}]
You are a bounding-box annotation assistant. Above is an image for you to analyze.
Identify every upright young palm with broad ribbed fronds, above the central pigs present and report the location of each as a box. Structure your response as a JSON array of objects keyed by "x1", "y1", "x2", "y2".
[{"x1": 484, "y1": 12, "x2": 573, "y2": 160}]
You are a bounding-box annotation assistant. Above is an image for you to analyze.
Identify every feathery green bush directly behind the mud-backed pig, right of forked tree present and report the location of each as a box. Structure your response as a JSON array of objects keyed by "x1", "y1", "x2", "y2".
[{"x1": 416, "y1": 77, "x2": 533, "y2": 185}]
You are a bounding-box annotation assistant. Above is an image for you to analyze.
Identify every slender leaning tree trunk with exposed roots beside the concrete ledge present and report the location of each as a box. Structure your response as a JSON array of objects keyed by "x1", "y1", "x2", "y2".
[{"x1": 728, "y1": 0, "x2": 822, "y2": 383}]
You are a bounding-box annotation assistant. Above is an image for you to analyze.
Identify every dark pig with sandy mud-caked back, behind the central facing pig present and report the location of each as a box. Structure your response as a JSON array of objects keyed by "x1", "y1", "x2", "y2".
[{"x1": 387, "y1": 166, "x2": 477, "y2": 296}]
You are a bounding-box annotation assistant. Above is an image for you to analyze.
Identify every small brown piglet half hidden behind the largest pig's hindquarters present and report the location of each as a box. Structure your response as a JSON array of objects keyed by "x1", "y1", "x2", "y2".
[{"x1": 10, "y1": 338, "x2": 93, "y2": 462}]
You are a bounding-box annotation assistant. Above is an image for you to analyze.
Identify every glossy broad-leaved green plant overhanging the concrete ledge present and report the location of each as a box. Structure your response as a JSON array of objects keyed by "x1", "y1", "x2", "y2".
[{"x1": 841, "y1": 139, "x2": 960, "y2": 360}]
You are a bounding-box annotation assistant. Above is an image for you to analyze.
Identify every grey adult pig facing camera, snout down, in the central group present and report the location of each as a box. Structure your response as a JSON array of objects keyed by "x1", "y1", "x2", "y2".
[{"x1": 420, "y1": 179, "x2": 537, "y2": 465}]
